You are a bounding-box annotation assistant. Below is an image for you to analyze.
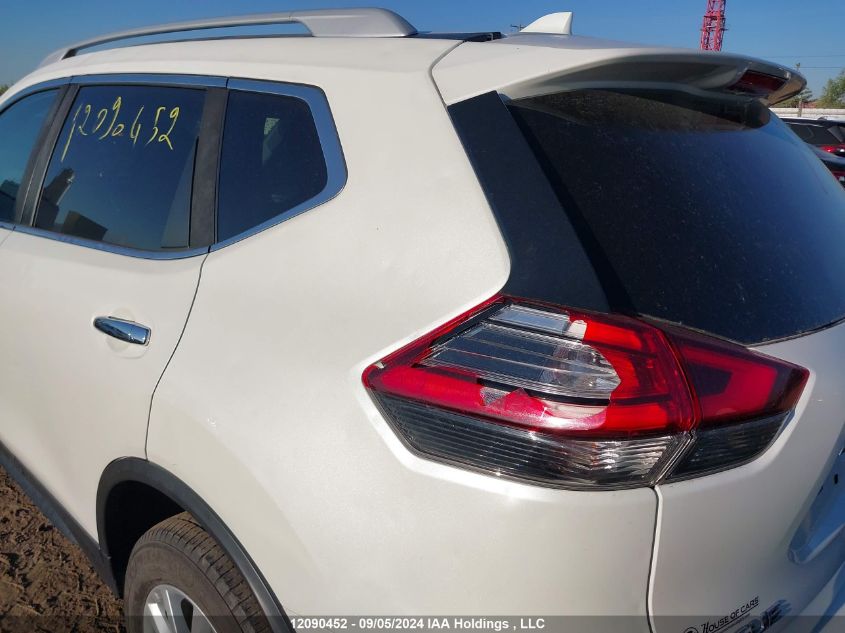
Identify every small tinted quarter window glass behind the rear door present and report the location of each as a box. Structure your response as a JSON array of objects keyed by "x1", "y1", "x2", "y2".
[{"x1": 217, "y1": 92, "x2": 327, "y2": 240}]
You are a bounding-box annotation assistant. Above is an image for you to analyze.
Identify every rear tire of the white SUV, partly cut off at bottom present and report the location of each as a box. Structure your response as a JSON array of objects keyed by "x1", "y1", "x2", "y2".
[{"x1": 124, "y1": 513, "x2": 270, "y2": 633}]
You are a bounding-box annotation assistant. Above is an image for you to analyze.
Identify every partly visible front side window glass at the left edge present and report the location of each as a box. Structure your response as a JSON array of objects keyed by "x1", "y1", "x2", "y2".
[{"x1": 0, "y1": 90, "x2": 56, "y2": 222}]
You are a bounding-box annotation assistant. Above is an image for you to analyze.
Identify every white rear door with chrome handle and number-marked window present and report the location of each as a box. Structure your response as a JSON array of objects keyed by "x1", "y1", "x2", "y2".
[{"x1": 0, "y1": 79, "x2": 213, "y2": 534}]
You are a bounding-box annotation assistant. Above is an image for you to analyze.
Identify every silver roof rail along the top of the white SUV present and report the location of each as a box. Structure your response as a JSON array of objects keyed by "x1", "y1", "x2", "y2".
[{"x1": 41, "y1": 8, "x2": 417, "y2": 66}]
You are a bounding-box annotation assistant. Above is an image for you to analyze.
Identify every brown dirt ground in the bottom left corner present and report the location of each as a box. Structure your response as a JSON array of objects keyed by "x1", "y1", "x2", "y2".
[{"x1": 0, "y1": 469, "x2": 123, "y2": 633}]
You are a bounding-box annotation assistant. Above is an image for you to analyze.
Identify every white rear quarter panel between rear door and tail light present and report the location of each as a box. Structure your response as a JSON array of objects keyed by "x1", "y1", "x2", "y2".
[{"x1": 147, "y1": 54, "x2": 656, "y2": 626}]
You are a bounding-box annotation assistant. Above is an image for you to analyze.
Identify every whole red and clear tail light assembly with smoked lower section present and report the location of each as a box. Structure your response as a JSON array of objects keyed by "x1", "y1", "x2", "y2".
[{"x1": 363, "y1": 297, "x2": 808, "y2": 488}]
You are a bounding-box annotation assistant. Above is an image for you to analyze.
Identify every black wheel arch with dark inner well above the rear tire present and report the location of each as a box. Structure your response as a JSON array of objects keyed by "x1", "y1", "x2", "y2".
[{"x1": 97, "y1": 457, "x2": 293, "y2": 633}]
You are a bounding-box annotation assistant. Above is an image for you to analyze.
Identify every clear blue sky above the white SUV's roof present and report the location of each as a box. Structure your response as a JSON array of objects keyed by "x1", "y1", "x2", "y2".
[{"x1": 0, "y1": 0, "x2": 845, "y2": 96}]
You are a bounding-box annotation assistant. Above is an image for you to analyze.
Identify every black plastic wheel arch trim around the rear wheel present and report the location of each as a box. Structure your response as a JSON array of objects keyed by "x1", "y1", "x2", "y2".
[{"x1": 97, "y1": 457, "x2": 294, "y2": 633}]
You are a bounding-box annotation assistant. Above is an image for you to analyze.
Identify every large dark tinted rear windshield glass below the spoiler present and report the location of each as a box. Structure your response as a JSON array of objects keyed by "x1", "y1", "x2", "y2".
[{"x1": 510, "y1": 90, "x2": 845, "y2": 344}]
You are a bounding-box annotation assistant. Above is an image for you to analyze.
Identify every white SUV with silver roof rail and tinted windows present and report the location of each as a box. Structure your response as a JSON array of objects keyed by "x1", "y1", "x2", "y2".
[{"x1": 0, "y1": 9, "x2": 845, "y2": 633}]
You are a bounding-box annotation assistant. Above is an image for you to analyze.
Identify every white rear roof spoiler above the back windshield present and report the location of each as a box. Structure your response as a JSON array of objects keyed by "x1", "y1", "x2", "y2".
[{"x1": 434, "y1": 32, "x2": 807, "y2": 105}]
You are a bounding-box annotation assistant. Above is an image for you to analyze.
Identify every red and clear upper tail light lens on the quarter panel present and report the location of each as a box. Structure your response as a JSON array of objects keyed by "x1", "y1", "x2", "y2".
[{"x1": 365, "y1": 303, "x2": 693, "y2": 436}]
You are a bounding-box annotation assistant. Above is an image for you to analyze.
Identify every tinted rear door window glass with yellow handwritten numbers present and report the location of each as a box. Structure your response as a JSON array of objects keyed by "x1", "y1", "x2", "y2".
[{"x1": 35, "y1": 86, "x2": 205, "y2": 250}]
